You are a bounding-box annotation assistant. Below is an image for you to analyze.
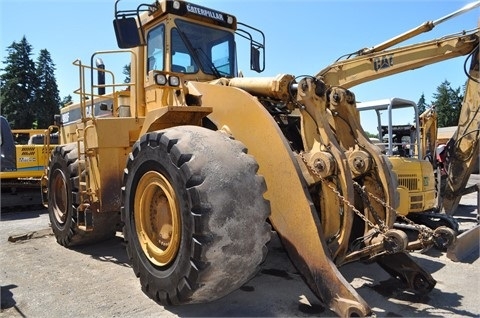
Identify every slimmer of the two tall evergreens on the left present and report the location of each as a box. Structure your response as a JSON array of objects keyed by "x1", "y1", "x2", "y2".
[{"x1": 35, "y1": 49, "x2": 60, "y2": 128}]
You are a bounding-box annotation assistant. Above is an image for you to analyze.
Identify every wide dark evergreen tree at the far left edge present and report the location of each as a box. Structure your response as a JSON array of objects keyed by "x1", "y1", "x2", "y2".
[{"x1": 0, "y1": 36, "x2": 38, "y2": 129}]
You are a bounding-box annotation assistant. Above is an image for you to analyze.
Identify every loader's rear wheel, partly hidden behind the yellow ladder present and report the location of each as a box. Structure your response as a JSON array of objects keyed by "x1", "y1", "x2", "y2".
[{"x1": 48, "y1": 143, "x2": 120, "y2": 247}]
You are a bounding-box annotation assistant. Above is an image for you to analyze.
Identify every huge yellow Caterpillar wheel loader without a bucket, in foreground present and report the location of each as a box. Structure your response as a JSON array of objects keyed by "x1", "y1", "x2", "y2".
[{"x1": 42, "y1": 1, "x2": 478, "y2": 316}]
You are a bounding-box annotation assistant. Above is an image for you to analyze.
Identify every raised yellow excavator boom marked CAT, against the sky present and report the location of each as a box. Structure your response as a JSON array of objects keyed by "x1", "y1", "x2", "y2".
[{"x1": 316, "y1": 1, "x2": 480, "y2": 88}]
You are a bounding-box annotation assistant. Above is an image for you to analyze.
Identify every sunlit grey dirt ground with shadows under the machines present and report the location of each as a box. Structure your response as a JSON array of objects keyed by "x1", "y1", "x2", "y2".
[{"x1": 0, "y1": 180, "x2": 480, "y2": 317}]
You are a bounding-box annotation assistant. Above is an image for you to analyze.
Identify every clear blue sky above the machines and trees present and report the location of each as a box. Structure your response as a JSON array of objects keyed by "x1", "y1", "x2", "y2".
[{"x1": 0, "y1": 0, "x2": 480, "y2": 131}]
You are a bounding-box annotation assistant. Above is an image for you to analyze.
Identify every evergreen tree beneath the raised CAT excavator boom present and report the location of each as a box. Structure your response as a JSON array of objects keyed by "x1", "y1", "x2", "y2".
[{"x1": 433, "y1": 80, "x2": 463, "y2": 127}]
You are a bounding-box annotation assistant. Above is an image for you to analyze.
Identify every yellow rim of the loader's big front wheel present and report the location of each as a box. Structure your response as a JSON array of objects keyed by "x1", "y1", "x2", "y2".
[{"x1": 134, "y1": 171, "x2": 181, "y2": 266}]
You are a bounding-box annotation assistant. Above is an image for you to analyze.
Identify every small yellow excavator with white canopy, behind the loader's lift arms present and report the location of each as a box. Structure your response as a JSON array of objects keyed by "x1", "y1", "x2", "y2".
[{"x1": 357, "y1": 97, "x2": 437, "y2": 216}]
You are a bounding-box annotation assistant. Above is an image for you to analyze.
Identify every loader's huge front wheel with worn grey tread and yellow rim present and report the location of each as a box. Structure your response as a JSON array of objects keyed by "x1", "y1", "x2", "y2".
[{"x1": 122, "y1": 126, "x2": 270, "y2": 305}]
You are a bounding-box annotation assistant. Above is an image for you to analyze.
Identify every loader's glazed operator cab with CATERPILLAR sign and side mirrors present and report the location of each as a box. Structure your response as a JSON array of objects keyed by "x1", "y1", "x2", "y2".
[{"x1": 114, "y1": 0, "x2": 265, "y2": 81}]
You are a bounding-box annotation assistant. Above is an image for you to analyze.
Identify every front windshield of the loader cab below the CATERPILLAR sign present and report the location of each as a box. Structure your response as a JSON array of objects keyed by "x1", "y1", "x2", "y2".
[{"x1": 171, "y1": 19, "x2": 236, "y2": 77}]
